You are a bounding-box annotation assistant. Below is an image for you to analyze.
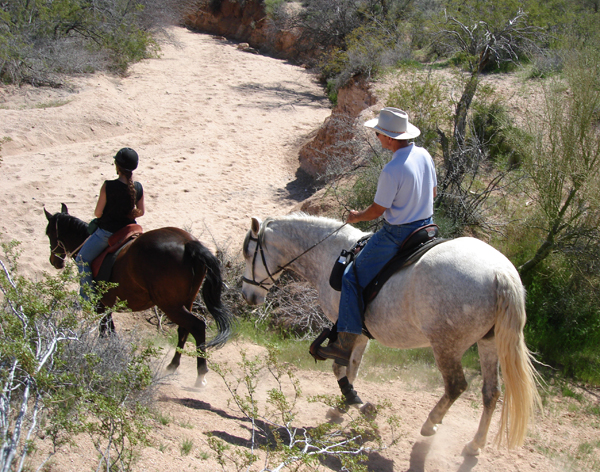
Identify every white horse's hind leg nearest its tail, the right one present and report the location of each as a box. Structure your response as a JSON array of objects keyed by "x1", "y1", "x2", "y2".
[{"x1": 464, "y1": 336, "x2": 500, "y2": 456}]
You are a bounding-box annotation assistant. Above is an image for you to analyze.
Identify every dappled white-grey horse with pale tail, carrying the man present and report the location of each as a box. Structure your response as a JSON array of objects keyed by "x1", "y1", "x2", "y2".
[{"x1": 242, "y1": 214, "x2": 541, "y2": 455}]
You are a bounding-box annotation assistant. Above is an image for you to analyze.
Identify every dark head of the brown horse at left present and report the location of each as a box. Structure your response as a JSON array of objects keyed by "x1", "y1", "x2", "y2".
[{"x1": 44, "y1": 203, "x2": 87, "y2": 269}]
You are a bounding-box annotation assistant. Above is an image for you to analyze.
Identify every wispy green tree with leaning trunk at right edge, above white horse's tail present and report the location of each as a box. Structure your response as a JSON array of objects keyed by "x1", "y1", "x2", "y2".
[{"x1": 519, "y1": 50, "x2": 600, "y2": 276}]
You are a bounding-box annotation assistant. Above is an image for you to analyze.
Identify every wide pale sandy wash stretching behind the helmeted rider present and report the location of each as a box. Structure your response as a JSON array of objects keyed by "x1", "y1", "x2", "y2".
[{"x1": 0, "y1": 28, "x2": 330, "y2": 274}]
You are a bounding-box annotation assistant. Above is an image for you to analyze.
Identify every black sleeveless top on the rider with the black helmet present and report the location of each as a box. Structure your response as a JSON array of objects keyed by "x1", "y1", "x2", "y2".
[{"x1": 98, "y1": 179, "x2": 144, "y2": 233}]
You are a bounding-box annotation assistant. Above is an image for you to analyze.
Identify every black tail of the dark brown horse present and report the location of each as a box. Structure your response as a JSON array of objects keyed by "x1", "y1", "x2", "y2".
[{"x1": 185, "y1": 241, "x2": 233, "y2": 348}]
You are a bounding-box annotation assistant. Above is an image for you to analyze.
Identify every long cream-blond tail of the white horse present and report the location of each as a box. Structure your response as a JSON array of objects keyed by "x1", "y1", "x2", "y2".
[{"x1": 494, "y1": 271, "x2": 542, "y2": 449}]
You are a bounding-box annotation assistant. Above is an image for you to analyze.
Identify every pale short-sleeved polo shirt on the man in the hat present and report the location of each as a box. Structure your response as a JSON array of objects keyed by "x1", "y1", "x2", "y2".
[{"x1": 374, "y1": 143, "x2": 437, "y2": 225}]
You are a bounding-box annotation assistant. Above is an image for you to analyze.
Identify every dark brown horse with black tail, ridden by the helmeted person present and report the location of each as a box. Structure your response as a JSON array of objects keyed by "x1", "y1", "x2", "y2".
[{"x1": 44, "y1": 203, "x2": 232, "y2": 386}]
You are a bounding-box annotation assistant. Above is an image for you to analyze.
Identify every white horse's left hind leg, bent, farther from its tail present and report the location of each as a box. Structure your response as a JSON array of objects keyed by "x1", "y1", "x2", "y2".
[{"x1": 421, "y1": 349, "x2": 468, "y2": 436}]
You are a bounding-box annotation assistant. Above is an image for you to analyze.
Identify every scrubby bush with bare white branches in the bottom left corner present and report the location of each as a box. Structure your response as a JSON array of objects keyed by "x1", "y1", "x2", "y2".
[{"x1": 0, "y1": 243, "x2": 156, "y2": 471}]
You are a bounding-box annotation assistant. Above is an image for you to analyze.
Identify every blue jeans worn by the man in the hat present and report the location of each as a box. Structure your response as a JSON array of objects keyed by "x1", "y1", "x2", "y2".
[{"x1": 337, "y1": 218, "x2": 433, "y2": 334}]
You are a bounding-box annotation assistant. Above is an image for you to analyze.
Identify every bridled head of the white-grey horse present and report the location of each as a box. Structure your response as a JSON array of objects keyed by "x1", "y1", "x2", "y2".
[{"x1": 242, "y1": 218, "x2": 281, "y2": 305}]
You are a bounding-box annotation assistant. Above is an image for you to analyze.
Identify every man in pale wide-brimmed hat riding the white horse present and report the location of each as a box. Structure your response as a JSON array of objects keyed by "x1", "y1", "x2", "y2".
[{"x1": 317, "y1": 107, "x2": 437, "y2": 366}]
